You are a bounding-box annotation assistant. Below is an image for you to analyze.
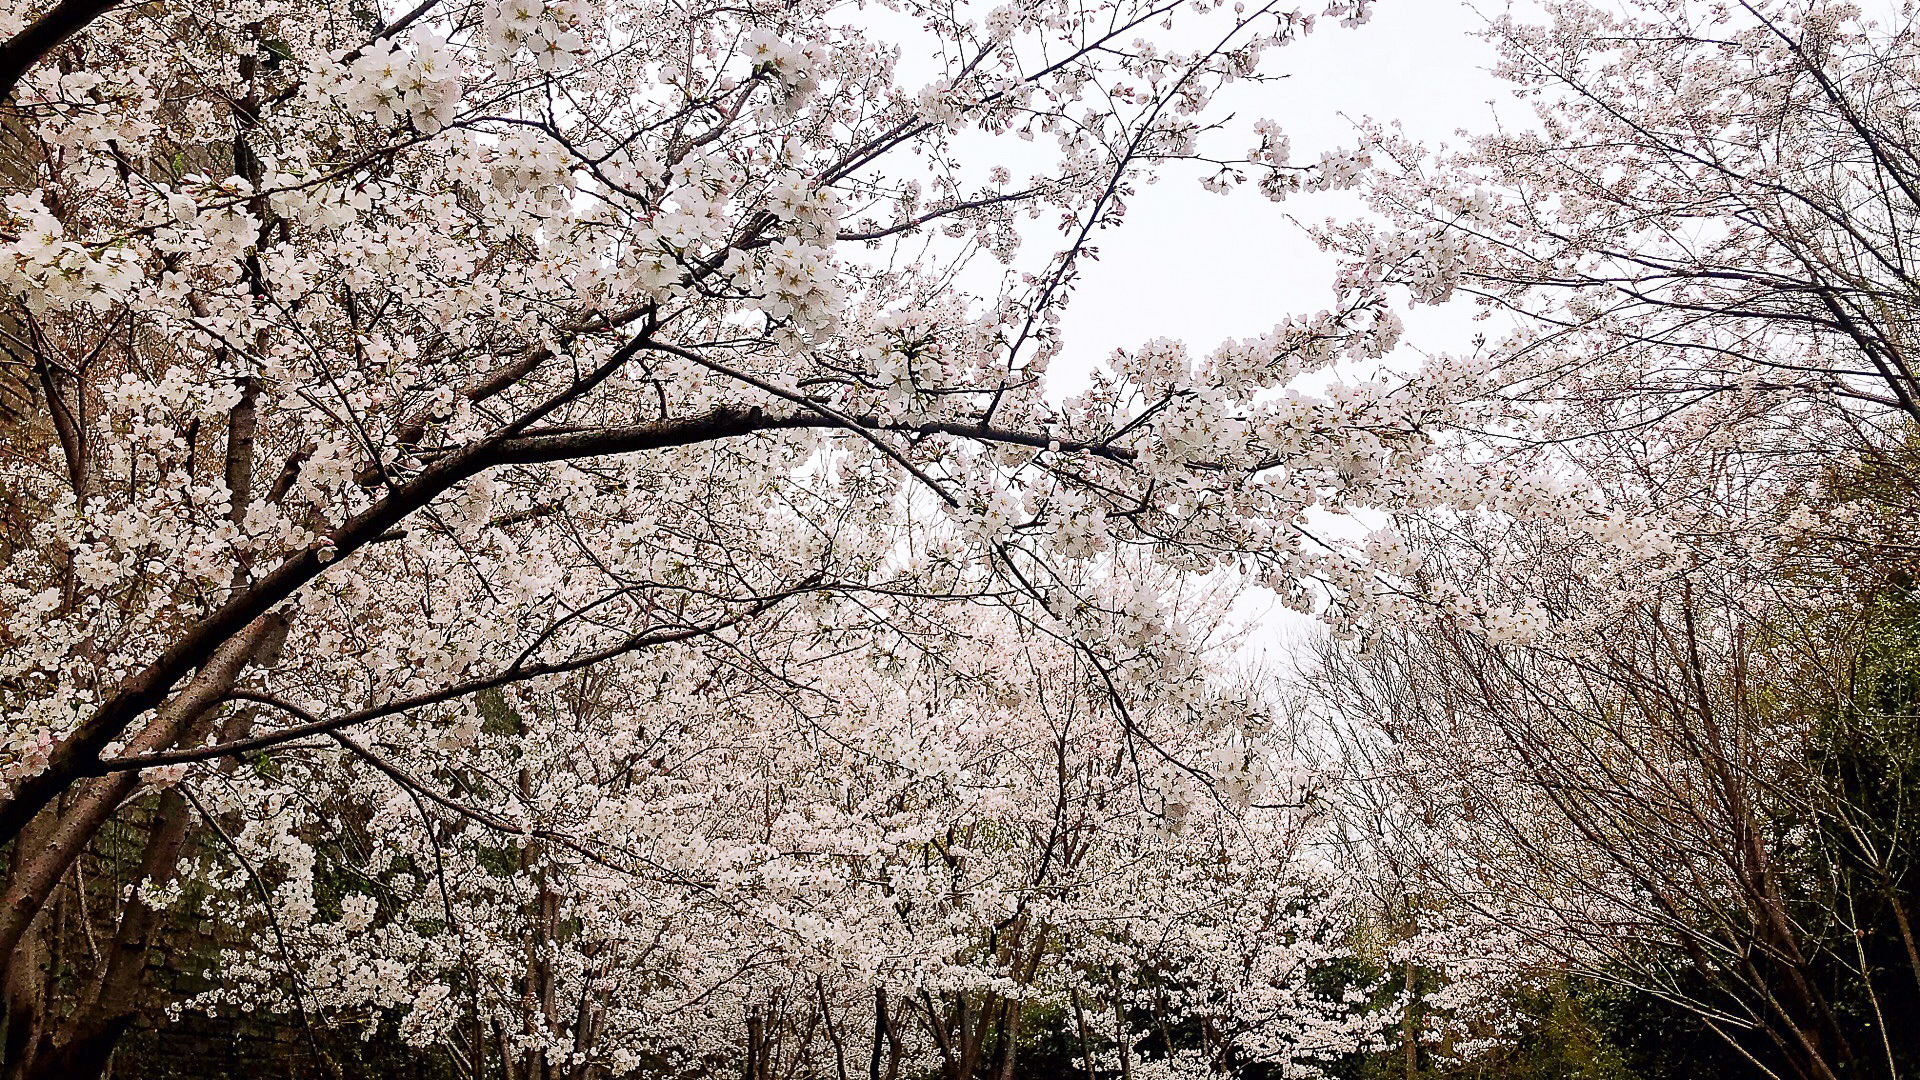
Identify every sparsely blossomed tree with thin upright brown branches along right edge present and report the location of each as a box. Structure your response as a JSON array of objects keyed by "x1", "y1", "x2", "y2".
[{"x1": 1297, "y1": 0, "x2": 1920, "y2": 1076}]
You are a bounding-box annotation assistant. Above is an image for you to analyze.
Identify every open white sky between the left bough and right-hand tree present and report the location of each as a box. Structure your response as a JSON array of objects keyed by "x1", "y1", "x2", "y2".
[{"x1": 1052, "y1": 0, "x2": 1517, "y2": 382}]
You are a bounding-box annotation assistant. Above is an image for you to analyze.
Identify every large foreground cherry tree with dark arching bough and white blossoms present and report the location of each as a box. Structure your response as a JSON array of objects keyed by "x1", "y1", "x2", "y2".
[{"x1": 0, "y1": 0, "x2": 1448, "y2": 1074}]
